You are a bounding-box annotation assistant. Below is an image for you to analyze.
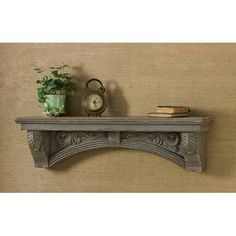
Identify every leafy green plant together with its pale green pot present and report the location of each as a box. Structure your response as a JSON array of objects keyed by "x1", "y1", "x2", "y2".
[{"x1": 34, "y1": 64, "x2": 76, "y2": 116}]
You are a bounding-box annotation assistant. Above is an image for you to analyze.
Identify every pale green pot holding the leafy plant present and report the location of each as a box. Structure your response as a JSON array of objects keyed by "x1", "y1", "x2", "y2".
[{"x1": 43, "y1": 95, "x2": 66, "y2": 116}]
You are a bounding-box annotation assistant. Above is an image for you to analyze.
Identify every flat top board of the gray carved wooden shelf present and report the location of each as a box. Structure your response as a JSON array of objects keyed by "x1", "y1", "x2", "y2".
[{"x1": 15, "y1": 116, "x2": 213, "y2": 125}]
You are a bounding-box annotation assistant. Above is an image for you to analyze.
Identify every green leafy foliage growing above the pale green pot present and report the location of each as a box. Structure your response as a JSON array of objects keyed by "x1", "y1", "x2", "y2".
[{"x1": 34, "y1": 63, "x2": 76, "y2": 103}]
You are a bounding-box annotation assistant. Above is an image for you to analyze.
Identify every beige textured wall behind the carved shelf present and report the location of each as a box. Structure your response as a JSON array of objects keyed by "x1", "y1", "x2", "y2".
[{"x1": 0, "y1": 44, "x2": 236, "y2": 192}]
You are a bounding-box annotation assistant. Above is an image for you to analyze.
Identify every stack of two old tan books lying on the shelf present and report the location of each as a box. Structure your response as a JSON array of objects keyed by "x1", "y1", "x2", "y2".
[{"x1": 148, "y1": 106, "x2": 190, "y2": 117}]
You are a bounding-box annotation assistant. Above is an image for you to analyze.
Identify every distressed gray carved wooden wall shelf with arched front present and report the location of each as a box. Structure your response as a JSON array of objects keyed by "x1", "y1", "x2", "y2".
[{"x1": 16, "y1": 116, "x2": 213, "y2": 172}]
